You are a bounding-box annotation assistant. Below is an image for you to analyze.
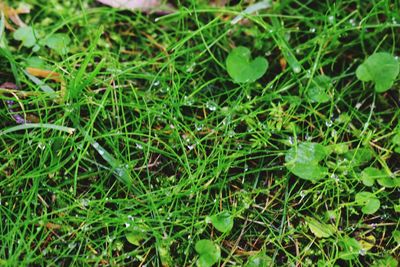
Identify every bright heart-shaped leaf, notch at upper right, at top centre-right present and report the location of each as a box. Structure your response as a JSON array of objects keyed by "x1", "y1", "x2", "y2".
[{"x1": 226, "y1": 46, "x2": 268, "y2": 83}]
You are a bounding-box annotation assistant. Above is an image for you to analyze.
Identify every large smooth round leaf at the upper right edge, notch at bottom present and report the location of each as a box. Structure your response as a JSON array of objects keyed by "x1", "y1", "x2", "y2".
[{"x1": 356, "y1": 52, "x2": 399, "y2": 93}]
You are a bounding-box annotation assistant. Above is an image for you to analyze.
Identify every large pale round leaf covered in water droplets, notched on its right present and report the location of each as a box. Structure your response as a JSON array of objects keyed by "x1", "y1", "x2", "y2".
[{"x1": 285, "y1": 142, "x2": 327, "y2": 182}]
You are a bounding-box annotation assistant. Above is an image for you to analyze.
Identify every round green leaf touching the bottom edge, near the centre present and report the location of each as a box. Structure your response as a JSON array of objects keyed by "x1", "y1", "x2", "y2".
[{"x1": 195, "y1": 239, "x2": 221, "y2": 267}]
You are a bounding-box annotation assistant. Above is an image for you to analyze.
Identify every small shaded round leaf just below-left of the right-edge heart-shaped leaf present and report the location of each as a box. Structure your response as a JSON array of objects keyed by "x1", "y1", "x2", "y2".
[{"x1": 307, "y1": 75, "x2": 332, "y2": 103}]
